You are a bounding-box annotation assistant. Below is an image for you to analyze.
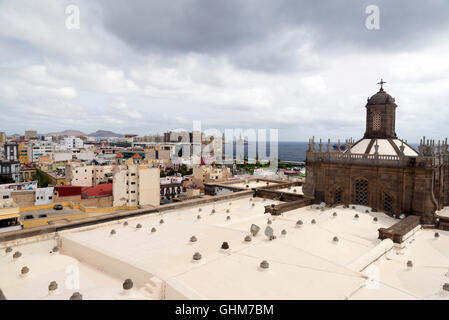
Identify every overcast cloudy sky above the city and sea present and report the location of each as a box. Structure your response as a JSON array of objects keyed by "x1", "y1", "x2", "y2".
[{"x1": 0, "y1": 0, "x2": 449, "y2": 141}]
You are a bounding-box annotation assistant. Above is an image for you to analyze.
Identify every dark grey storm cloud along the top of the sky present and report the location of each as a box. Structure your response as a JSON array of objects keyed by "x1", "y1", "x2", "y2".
[{"x1": 101, "y1": 0, "x2": 449, "y2": 60}]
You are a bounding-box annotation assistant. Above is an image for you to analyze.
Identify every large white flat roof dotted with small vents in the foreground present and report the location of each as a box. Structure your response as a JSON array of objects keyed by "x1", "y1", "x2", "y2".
[{"x1": 0, "y1": 197, "x2": 449, "y2": 299}]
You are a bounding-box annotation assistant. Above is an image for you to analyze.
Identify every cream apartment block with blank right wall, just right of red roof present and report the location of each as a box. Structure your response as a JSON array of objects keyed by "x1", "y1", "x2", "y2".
[{"x1": 112, "y1": 165, "x2": 160, "y2": 207}]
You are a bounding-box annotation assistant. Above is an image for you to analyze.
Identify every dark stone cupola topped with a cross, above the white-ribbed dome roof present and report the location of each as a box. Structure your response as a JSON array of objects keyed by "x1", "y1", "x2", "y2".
[{"x1": 363, "y1": 80, "x2": 397, "y2": 139}]
